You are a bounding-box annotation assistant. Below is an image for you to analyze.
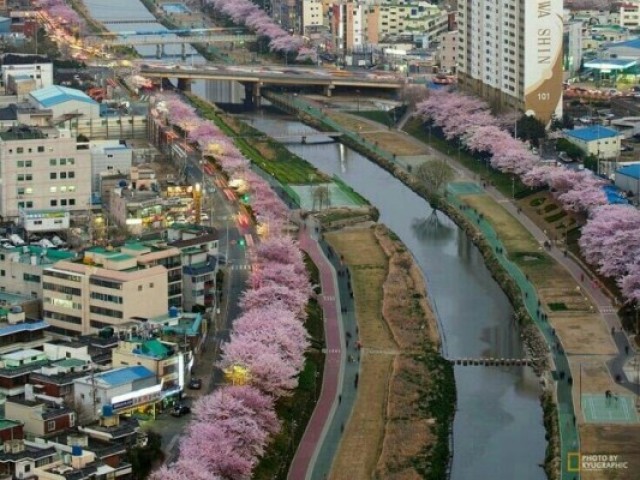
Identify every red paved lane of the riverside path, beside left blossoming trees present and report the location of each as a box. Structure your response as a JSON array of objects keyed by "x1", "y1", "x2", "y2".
[{"x1": 287, "y1": 229, "x2": 342, "y2": 480}]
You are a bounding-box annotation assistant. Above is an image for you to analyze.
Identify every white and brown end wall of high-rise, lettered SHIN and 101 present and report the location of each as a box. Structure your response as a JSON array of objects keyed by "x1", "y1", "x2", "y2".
[{"x1": 521, "y1": 0, "x2": 563, "y2": 123}]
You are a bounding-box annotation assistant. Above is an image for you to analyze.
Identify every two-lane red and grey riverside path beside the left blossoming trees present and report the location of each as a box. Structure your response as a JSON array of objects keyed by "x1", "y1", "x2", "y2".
[{"x1": 287, "y1": 219, "x2": 358, "y2": 480}]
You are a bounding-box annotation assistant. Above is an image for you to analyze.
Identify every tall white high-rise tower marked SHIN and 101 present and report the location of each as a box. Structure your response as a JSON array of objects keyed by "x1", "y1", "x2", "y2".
[{"x1": 457, "y1": 0, "x2": 563, "y2": 123}]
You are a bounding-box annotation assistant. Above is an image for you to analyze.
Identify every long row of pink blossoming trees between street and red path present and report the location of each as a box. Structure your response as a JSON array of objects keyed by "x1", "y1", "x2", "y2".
[{"x1": 151, "y1": 95, "x2": 311, "y2": 480}]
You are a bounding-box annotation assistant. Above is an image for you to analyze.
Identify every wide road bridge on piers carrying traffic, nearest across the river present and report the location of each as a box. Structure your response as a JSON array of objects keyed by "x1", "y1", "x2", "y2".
[{"x1": 140, "y1": 64, "x2": 407, "y2": 105}]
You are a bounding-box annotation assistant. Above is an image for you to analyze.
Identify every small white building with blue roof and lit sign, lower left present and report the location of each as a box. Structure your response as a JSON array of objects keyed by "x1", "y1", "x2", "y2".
[{"x1": 74, "y1": 365, "x2": 162, "y2": 421}]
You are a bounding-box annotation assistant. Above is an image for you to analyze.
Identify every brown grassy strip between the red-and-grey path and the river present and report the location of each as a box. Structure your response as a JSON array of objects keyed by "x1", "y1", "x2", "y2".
[{"x1": 323, "y1": 223, "x2": 456, "y2": 480}]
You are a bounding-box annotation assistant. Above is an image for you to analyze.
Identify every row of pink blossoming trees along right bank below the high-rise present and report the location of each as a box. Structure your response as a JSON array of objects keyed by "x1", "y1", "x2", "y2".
[{"x1": 417, "y1": 91, "x2": 640, "y2": 302}]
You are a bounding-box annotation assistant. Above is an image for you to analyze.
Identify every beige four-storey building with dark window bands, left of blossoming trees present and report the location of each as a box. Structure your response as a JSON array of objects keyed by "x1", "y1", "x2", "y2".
[{"x1": 42, "y1": 258, "x2": 168, "y2": 336}]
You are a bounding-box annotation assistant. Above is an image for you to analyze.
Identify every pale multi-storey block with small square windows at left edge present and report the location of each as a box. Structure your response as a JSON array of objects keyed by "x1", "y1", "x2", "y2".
[{"x1": 0, "y1": 126, "x2": 91, "y2": 219}]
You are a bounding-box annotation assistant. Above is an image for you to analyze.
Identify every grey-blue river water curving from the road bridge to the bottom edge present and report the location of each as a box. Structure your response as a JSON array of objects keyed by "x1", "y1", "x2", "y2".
[{"x1": 243, "y1": 111, "x2": 546, "y2": 480}]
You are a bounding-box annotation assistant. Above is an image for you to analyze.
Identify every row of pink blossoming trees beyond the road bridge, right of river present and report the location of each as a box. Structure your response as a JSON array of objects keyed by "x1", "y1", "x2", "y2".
[{"x1": 208, "y1": 0, "x2": 304, "y2": 57}]
